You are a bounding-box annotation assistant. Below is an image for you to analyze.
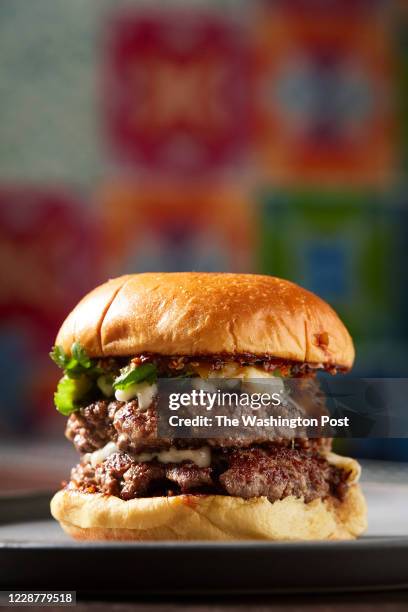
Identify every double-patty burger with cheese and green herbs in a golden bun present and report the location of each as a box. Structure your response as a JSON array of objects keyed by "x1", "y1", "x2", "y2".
[{"x1": 51, "y1": 273, "x2": 366, "y2": 541}]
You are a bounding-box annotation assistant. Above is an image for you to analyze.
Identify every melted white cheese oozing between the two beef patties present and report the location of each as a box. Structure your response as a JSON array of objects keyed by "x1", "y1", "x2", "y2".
[{"x1": 84, "y1": 442, "x2": 211, "y2": 468}]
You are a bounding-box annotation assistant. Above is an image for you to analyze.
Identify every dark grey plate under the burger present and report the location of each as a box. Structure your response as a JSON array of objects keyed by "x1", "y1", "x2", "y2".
[{"x1": 0, "y1": 495, "x2": 408, "y2": 595}]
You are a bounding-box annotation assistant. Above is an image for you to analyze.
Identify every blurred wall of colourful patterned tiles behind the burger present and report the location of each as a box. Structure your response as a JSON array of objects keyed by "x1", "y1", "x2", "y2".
[{"x1": 0, "y1": 0, "x2": 408, "y2": 478}]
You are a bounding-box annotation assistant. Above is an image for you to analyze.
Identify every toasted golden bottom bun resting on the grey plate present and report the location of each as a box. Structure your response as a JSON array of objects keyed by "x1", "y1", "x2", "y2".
[{"x1": 51, "y1": 484, "x2": 367, "y2": 541}]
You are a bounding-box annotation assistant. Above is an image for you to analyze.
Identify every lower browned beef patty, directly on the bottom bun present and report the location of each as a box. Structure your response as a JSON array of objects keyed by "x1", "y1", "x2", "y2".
[{"x1": 68, "y1": 446, "x2": 347, "y2": 502}]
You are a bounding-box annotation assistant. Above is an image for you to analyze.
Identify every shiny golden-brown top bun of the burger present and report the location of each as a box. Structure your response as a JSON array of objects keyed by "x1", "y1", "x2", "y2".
[{"x1": 56, "y1": 272, "x2": 354, "y2": 369}]
